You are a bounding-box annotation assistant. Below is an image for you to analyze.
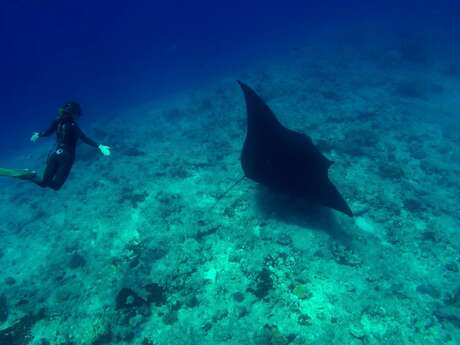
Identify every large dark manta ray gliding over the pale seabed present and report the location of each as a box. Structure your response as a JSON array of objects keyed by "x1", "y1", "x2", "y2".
[{"x1": 238, "y1": 81, "x2": 353, "y2": 217}]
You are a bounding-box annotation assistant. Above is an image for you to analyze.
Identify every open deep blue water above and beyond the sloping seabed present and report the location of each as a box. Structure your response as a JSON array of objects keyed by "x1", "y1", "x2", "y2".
[{"x1": 0, "y1": 0, "x2": 458, "y2": 151}]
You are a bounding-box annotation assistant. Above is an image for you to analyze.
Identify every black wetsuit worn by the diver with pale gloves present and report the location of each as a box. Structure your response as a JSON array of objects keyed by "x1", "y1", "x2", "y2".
[{"x1": 33, "y1": 117, "x2": 98, "y2": 190}]
